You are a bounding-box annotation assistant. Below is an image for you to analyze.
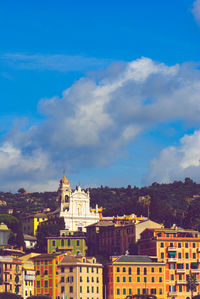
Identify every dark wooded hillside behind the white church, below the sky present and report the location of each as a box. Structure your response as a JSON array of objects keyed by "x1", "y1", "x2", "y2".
[{"x1": 0, "y1": 178, "x2": 200, "y2": 229}]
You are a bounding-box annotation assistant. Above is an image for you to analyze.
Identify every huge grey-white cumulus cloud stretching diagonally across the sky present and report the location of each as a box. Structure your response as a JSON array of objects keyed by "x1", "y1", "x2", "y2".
[{"x1": 0, "y1": 58, "x2": 200, "y2": 188}]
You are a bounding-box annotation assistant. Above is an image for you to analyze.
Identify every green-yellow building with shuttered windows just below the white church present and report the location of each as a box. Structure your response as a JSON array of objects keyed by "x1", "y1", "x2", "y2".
[{"x1": 47, "y1": 230, "x2": 87, "y2": 256}]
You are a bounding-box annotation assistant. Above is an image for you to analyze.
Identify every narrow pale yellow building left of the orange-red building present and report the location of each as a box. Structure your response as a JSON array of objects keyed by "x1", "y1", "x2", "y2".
[{"x1": 19, "y1": 253, "x2": 39, "y2": 299}]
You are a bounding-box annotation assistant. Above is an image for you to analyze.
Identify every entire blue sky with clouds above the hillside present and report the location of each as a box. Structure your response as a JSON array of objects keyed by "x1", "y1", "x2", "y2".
[{"x1": 0, "y1": 0, "x2": 200, "y2": 191}]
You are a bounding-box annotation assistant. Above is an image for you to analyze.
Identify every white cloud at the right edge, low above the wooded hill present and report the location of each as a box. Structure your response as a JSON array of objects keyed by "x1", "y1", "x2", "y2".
[{"x1": 148, "y1": 130, "x2": 200, "y2": 183}]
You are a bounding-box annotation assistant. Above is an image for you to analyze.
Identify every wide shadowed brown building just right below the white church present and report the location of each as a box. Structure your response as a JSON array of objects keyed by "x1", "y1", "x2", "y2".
[{"x1": 87, "y1": 214, "x2": 162, "y2": 256}]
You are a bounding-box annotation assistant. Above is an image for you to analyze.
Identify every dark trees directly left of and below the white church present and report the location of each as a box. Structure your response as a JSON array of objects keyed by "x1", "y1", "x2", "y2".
[{"x1": 35, "y1": 218, "x2": 65, "y2": 252}]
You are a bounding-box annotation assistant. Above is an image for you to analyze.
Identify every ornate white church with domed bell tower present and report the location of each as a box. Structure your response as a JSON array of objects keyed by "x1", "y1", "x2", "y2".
[{"x1": 58, "y1": 176, "x2": 100, "y2": 232}]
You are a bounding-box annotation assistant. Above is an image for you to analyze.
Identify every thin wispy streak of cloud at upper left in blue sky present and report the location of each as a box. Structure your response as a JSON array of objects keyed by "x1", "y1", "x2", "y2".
[{"x1": 0, "y1": 53, "x2": 109, "y2": 72}]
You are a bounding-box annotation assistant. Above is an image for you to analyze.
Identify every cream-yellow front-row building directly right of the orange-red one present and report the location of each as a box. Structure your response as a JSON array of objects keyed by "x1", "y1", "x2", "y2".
[{"x1": 58, "y1": 255, "x2": 103, "y2": 299}]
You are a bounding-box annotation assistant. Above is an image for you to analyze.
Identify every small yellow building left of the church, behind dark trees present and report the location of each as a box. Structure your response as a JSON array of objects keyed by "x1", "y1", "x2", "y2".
[{"x1": 22, "y1": 213, "x2": 48, "y2": 236}]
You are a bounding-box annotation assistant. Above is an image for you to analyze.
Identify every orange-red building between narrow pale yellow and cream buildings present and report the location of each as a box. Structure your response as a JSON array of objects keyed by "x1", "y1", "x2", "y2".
[{"x1": 32, "y1": 253, "x2": 64, "y2": 299}]
